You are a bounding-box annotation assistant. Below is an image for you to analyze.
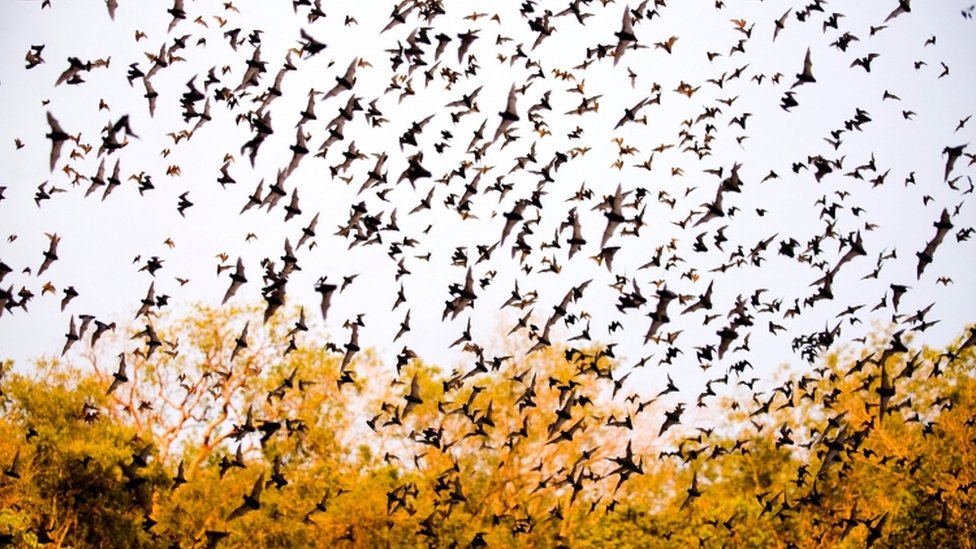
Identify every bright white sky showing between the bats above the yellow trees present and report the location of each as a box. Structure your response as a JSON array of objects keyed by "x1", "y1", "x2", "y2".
[{"x1": 0, "y1": 0, "x2": 976, "y2": 412}]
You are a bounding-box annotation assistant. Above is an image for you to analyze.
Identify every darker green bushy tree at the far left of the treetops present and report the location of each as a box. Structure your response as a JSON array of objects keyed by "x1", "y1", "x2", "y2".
[{"x1": 3, "y1": 364, "x2": 162, "y2": 547}]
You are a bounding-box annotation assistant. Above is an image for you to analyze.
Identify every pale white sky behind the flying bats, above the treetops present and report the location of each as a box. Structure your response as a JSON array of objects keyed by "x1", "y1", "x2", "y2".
[{"x1": 0, "y1": 0, "x2": 976, "y2": 412}]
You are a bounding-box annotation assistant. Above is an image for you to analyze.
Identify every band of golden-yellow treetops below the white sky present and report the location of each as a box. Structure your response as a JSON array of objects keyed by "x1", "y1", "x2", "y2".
[{"x1": 0, "y1": 308, "x2": 976, "y2": 547}]
